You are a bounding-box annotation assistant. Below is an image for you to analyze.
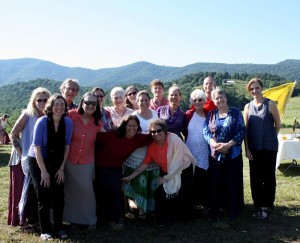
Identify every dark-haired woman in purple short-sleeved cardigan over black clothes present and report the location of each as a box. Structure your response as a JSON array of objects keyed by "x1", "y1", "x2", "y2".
[{"x1": 28, "y1": 94, "x2": 73, "y2": 240}]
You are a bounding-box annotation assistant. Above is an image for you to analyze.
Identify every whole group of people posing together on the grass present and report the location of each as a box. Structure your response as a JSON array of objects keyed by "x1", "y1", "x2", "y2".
[{"x1": 8, "y1": 77, "x2": 280, "y2": 240}]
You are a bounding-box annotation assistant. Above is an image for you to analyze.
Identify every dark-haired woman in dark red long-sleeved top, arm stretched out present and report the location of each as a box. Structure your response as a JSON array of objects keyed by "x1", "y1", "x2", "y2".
[{"x1": 95, "y1": 115, "x2": 152, "y2": 228}]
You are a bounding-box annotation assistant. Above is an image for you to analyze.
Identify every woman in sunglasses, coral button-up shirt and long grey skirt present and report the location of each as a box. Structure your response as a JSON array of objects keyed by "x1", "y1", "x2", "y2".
[{"x1": 64, "y1": 93, "x2": 102, "y2": 229}]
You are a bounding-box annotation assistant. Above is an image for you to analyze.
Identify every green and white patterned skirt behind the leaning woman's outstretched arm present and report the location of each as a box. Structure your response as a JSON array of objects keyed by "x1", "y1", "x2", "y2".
[{"x1": 123, "y1": 147, "x2": 159, "y2": 212}]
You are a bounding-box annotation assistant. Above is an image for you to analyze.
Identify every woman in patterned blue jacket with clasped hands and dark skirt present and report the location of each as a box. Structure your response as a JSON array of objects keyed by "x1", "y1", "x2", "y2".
[{"x1": 203, "y1": 88, "x2": 245, "y2": 219}]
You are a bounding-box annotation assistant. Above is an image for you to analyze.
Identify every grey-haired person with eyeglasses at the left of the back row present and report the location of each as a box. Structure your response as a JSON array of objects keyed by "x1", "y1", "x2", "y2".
[{"x1": 59, "y1": 78, "x2": 79, "y2": 110}]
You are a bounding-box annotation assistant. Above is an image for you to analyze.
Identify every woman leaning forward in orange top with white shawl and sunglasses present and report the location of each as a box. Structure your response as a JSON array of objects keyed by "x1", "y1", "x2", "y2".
[{"x1": 122, "y1": 118, "x2": 196, "y2": 226}]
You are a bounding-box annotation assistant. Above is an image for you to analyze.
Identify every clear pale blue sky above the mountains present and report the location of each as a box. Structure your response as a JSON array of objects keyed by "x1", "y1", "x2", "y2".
[{"x1": 0, "y1": 0, "x2": 300, "y2": 69}]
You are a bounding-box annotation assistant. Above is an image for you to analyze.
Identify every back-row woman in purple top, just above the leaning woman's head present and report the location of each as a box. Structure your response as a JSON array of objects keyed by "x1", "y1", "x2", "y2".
[{"x1": 157, "y1": 84, "x2": 187, "y2": 140}]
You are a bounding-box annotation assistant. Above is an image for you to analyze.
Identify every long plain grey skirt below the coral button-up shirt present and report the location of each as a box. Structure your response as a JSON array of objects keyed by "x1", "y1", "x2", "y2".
[{"x1": 64, "y1": 161, "x2": 97, "y2": 225}]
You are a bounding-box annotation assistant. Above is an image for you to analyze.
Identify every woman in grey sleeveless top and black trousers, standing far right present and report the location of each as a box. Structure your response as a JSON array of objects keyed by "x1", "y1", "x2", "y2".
[{"x1": 244, "y1": 78, "x2": 280, "y2": 219}]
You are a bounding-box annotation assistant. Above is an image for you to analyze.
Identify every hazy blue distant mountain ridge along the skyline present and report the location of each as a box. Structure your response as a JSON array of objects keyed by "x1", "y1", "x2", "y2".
[{"x1": 0, "y1": 58, "x2": 300, "y2": 89}]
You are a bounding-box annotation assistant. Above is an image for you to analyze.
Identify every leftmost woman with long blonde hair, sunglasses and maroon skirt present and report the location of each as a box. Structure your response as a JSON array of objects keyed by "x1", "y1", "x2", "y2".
[{"x1": 7, "y1": 87, "x2": 51, "y2": 231}]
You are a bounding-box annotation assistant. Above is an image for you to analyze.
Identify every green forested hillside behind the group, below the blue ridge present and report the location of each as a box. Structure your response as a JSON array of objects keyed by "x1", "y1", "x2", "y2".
[{"x1": 0, "y1": 72, "x2": 300, "y2": 133}]
